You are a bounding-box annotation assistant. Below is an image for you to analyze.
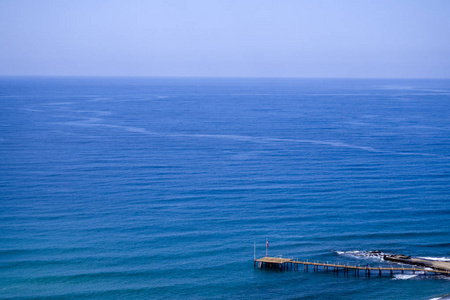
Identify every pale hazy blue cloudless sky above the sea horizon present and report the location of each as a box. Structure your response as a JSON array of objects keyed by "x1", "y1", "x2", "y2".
[{"x1": 0, "y1": 0, "x2": 450, "y2": 78}]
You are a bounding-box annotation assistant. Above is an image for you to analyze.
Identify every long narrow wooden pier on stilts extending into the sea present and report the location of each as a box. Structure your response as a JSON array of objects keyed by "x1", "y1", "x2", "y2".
[{"x1": 253, "y1": 257, "x2": 450, "y2": 277}]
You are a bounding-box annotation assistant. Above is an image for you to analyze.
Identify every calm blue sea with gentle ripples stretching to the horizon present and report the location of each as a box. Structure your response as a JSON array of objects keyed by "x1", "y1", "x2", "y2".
[{"x1": 0, "y1": 77, "x2": 450, "y2": 299}]
